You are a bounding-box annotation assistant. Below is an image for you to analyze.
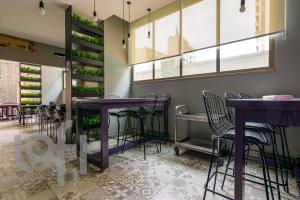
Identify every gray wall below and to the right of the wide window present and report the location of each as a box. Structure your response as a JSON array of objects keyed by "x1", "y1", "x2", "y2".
[{"x1": 132, "y1": 0, "x2": 300, "y2": 157}]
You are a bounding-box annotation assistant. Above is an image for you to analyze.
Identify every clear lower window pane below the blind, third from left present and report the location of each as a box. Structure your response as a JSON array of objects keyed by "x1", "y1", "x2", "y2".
[{"x1": 182, "y1": 48, "x2": 217, "y2": 75}]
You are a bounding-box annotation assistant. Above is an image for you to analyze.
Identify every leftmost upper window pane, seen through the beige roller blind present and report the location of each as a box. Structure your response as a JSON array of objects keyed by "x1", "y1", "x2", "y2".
[{"x1": 131, "y1": 23, "x2": 153, "y2": 63}]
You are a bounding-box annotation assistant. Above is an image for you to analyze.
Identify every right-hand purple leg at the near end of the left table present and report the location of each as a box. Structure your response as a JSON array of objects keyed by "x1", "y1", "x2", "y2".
[{"x1": 100, "y1": 106, "x2": 109, "y2": 170}]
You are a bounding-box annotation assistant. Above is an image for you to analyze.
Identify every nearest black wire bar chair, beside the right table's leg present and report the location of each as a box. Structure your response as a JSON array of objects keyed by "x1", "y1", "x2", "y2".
[{"x1": 203, "y1": 91, "x2": 274, "y2": 199}]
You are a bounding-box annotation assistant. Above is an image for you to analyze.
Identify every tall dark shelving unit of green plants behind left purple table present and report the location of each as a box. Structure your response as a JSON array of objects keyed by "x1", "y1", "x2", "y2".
[{"x1": 65, "y1": 6, "x2": 104, "y2": 141}]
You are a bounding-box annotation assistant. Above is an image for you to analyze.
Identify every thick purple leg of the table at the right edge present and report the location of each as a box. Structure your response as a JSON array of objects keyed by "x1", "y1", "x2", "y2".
[{"x1": 234, "y1": 109, "x2": 245, "y2": 200}]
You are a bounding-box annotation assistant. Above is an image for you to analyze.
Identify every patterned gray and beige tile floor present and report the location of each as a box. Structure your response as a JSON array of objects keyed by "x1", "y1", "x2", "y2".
[{"x1": 0, "y1": 122, "x2": 297, "y2": 200}]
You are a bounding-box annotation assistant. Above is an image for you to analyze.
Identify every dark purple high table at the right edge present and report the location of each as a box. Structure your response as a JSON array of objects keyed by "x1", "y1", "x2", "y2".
[{"x1": 227, "y1": 99, "x2": 300, "y2": 200}]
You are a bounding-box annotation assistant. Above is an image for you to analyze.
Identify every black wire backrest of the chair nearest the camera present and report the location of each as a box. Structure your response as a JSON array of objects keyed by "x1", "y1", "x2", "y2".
[{"x1": 203, "y1": 90, "x2": 234, "y2": 136}]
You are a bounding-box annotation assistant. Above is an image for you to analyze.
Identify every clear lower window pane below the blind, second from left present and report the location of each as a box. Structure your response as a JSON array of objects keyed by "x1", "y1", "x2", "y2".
[{"x1": 155, "y1": 57, "x2": 180, "y2": 78}]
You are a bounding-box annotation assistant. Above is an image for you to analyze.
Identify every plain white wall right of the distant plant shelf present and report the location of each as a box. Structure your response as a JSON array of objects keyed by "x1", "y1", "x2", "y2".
[{"x1": 42, "y1": 66, "x2": 64, "y2": 105}]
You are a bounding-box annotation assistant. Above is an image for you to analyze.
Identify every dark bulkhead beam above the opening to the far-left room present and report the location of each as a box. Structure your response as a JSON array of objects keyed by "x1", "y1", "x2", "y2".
[{"x1": 0, "y1": 43, "x2": 65, "y2": 68}]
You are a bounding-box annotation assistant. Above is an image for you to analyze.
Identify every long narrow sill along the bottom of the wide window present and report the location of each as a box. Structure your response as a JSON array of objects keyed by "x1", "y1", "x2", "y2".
[{"x1": 132, "y1": 67, "x2": 275, "y2": 83}]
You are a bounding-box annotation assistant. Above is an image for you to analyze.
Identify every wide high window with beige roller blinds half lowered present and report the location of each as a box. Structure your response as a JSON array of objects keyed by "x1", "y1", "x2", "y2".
[{"x1": 131, "y1": 0, "x2": 285, "y2": 81}]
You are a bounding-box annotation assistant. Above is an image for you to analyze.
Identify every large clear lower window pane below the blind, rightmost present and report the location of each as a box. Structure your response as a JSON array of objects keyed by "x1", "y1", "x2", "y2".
[{"x1": 220, "y1": 36, "x2": 269, "y2": 71}]
